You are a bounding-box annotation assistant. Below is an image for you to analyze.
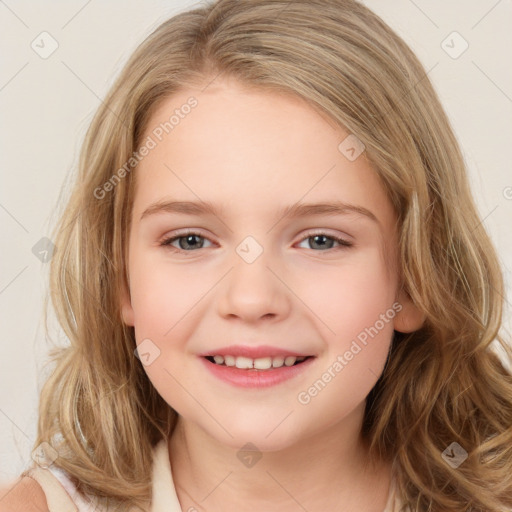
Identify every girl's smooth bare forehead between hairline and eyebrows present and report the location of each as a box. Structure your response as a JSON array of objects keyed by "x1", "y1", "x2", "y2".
[{"x1": 134, "y1": 81, "x2": 393, "y2": 230}]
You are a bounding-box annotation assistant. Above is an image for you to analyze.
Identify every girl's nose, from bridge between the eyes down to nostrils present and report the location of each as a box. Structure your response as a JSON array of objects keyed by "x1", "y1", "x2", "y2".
[{"x1": 214, "y1": 236, "x2": 290, "y2": 321}]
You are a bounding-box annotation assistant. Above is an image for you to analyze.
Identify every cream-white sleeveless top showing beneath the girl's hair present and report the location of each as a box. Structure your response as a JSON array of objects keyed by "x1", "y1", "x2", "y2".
[{"x1": 26, "y1": 439, "x2": 399, "y2": 512}]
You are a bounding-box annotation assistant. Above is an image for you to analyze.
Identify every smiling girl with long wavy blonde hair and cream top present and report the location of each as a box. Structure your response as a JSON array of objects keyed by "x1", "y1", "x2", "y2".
[{"x1": 0, "y1": 0, "x2": 512, "y2": 512}]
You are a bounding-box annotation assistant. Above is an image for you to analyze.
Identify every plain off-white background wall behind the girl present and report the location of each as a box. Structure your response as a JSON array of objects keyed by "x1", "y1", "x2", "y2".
[{"x1": 0, "y1": 0, "x2": 512, "y2": 482}]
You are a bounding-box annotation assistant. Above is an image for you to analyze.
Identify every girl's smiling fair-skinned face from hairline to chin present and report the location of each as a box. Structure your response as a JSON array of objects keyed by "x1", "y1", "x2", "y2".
[{"x1": 122, "y1": 76, "x2": 421, "y2": 451}]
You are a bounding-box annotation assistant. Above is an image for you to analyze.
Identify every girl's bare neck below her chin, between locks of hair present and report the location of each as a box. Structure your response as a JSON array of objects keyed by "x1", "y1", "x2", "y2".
[{"x1": 169, "y1": 404, "x2": 391, "y2": 512}]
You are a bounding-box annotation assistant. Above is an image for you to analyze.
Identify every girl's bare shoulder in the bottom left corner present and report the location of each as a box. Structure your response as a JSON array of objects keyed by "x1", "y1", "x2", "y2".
[{"x1": 0, "y1": 476, "x2": 48, "y2": 512}]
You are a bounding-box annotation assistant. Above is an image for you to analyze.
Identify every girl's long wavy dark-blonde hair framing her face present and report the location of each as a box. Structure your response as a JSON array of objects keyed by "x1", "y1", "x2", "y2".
[{"x1": 27, "y1": 0, "x2": 512, "y2": 512}]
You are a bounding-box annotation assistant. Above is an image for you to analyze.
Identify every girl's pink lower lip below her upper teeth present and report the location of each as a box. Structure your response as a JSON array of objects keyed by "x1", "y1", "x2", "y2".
[{"x1": 201, "y1": 357, "x2": 315, "y2": 388}]
